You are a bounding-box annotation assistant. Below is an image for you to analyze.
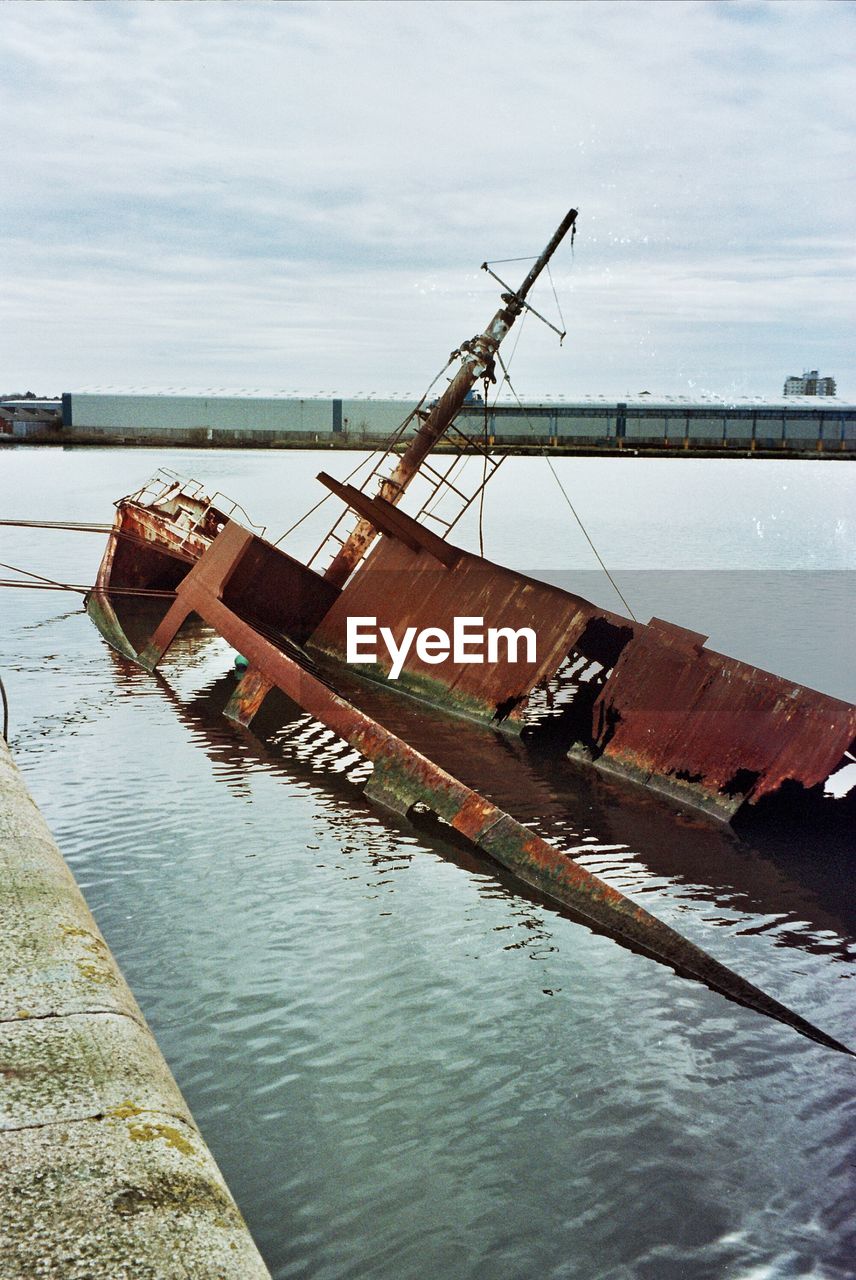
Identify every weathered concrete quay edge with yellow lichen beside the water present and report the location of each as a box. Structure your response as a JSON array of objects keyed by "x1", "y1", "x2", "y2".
[{"x1": 0, "y1": 737, "x2": 270, "y2": 1280}]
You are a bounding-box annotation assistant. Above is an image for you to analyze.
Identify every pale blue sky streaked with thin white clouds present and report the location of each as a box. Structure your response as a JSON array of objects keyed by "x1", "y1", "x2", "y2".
[{"x1": 0, "y1": 0, "x2": 856, "y2": 396}]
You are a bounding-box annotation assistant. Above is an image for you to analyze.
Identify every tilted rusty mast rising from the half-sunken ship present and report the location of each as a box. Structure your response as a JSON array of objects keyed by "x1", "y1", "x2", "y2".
[{"x1": 324, "y1": 209, "x2": 577, "y2": 586}]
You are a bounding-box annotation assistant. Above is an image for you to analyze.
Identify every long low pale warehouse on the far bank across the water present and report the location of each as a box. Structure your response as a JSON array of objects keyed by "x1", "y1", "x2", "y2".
[{"x1": 0, "y1": 390, "x2": 856, "y2": 453}]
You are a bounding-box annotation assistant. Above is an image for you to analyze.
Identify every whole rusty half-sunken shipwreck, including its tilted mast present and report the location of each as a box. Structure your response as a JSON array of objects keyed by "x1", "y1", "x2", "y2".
[{"x1": 87, "y1": 210, "x2": 856, "y2": 1052}]
